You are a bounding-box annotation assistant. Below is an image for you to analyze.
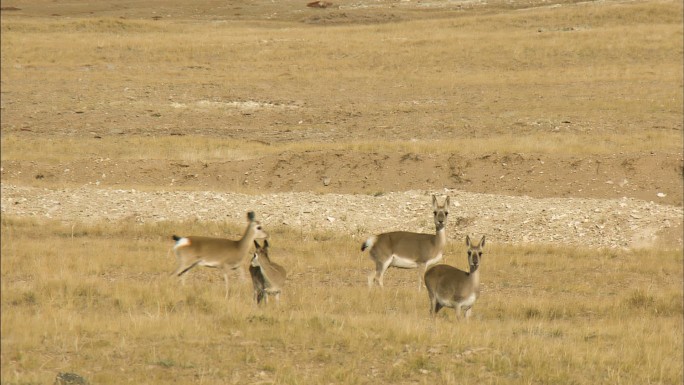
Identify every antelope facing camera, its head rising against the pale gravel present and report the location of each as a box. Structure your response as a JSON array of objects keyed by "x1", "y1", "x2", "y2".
[{"x1": 361, "y1": 195, "x2": 449, "y2": 290}]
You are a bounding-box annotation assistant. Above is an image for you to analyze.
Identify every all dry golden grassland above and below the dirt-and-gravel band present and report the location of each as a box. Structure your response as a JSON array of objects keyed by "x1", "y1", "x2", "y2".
[{"x1": 0, "y1": 1, "x2": 684, "y2": 385}]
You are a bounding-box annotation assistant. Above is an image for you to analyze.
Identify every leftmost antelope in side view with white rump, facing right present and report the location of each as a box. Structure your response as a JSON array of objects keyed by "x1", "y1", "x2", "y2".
[{"x1": 172, "y1": 211, "x2": 268, "y2": 298}]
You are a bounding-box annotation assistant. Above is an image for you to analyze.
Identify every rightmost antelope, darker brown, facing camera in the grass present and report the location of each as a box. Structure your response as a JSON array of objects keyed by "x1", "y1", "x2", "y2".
[{"x1": 425, "y1": 236, "x2": 485, "y2": 318}]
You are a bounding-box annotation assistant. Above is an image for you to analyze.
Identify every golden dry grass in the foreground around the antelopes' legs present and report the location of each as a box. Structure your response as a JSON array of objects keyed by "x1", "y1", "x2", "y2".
[{"x1": 2, "y1": 218, "x2": 684, "y2": 384}]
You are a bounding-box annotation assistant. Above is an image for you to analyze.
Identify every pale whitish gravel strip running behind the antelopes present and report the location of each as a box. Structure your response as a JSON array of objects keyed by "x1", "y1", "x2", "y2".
[{"x1": 2, "y1": 184, "x2": 683, "y2": 248}]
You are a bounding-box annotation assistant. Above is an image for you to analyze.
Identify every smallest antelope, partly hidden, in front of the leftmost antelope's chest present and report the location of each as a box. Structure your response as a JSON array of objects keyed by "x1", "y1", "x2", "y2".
[{"x1": 249, "y1": 240, "x2": 287, "y2": 304}]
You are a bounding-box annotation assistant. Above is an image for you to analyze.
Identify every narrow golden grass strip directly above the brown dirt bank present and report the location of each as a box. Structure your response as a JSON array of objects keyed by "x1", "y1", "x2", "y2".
[{"x1": 1, "y1": 131, "x2": 681, "y2": 163}]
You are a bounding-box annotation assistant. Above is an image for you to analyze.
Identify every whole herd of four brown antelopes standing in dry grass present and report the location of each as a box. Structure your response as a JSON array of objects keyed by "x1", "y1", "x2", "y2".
[{"x1": 172, "y1": 195, "x2": 485, "y2": 318}]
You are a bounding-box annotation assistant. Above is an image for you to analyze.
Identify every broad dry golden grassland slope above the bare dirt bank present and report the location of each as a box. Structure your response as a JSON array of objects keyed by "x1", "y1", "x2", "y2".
[{"x1": 0, "y1": 1, "x2": 684, "y2": 201}]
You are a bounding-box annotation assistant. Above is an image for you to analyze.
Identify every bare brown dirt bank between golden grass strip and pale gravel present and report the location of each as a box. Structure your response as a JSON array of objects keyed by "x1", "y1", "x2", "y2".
[{"x1": 2, "y1": 150, "x2": 682, "y2": 206}]
